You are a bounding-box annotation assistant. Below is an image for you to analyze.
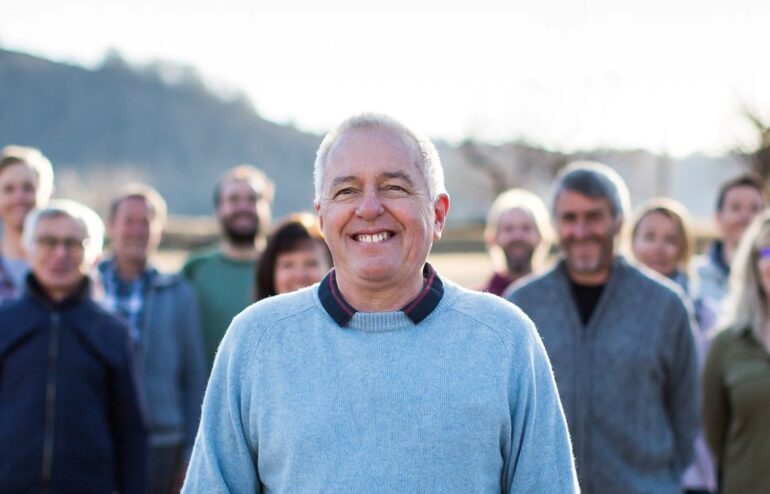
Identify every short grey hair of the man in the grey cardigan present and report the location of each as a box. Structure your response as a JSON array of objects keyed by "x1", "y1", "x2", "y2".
[{"x1": 551, "y1": 161, "x2": 631, "y2": 222}]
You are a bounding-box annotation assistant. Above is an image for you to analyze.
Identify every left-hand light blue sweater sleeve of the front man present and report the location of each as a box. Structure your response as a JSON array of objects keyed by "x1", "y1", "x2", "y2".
[{"x1": 182, "y1": 316, "x2": 262, "y2": 493}]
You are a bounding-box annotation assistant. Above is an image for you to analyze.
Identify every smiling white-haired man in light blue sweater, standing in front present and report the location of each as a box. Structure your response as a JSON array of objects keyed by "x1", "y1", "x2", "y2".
[{"x1": 185, "y1": 114, "x2": 577, "y2": 493}]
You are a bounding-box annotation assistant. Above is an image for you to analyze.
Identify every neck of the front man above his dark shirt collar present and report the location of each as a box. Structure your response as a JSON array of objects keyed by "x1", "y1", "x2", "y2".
[{"x1": 336, "y1": 272, "x2": 425, "y2": 312}]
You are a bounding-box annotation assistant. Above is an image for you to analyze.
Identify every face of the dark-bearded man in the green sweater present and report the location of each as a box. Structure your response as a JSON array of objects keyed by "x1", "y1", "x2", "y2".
[{"x1": 216, "y1": 180, "x2": 270, "y2": 246}]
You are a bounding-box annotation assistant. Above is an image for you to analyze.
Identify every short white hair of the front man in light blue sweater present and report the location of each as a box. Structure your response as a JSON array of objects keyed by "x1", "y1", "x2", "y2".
[{"x1": 313, "y1": 113, "x2": 446, "y2": 204}]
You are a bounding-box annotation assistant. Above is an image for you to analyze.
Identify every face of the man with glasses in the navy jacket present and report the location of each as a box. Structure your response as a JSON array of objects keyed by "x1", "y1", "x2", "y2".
[{"x1": 29, "y1": 216, "x2": 88, "y2": 300}]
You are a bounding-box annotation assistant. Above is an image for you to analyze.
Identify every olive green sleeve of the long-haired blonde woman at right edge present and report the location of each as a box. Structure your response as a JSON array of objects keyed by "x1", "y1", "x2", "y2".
[{"x1": 703, "y1": 330, "x2": 730, "y2": 463}]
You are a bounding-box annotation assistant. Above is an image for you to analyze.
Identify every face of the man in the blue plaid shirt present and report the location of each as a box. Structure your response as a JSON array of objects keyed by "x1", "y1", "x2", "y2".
[{"x1": 109, "y1": 197, "x2": 162, "y2": 264}]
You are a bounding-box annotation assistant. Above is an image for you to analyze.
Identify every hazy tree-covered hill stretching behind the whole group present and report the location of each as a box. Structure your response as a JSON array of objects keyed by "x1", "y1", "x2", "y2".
[{"x1": 0, "y1": 45, "x2": 746, "y2": 227}]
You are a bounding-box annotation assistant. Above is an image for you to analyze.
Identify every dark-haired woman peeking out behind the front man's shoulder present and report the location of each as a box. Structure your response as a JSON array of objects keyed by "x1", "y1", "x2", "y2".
[{"x1": 255, "y1": 213, "x2": 332, "y2": 300}]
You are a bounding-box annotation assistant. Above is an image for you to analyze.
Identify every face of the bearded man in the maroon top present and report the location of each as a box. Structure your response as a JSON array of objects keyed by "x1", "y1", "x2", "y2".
[{"x1": 494, "y1": 208, "x2": 542, "y2": 273}]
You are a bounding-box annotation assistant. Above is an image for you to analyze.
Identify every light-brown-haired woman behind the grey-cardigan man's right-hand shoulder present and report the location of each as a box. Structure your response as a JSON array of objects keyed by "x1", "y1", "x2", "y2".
[{"x1": 631, "y1": 198, "x2": 716, "y2": 494}]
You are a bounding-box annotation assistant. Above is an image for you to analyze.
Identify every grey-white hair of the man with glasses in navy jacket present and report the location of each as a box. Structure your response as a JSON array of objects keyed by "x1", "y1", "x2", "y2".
[{"x1": 21, "y1": 199, "x2": 104, "y2": 264}]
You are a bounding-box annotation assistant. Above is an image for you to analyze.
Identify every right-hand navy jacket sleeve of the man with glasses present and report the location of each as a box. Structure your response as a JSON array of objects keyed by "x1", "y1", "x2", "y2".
[{"x1": 111, "y1": 330, "x2": 149, "y2": 494}]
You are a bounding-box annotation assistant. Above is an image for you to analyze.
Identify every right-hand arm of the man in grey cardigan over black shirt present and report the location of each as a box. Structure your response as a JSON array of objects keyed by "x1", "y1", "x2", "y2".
[{"x1": 661, "y1": 301, "x2": 700, "y2": 475}]
